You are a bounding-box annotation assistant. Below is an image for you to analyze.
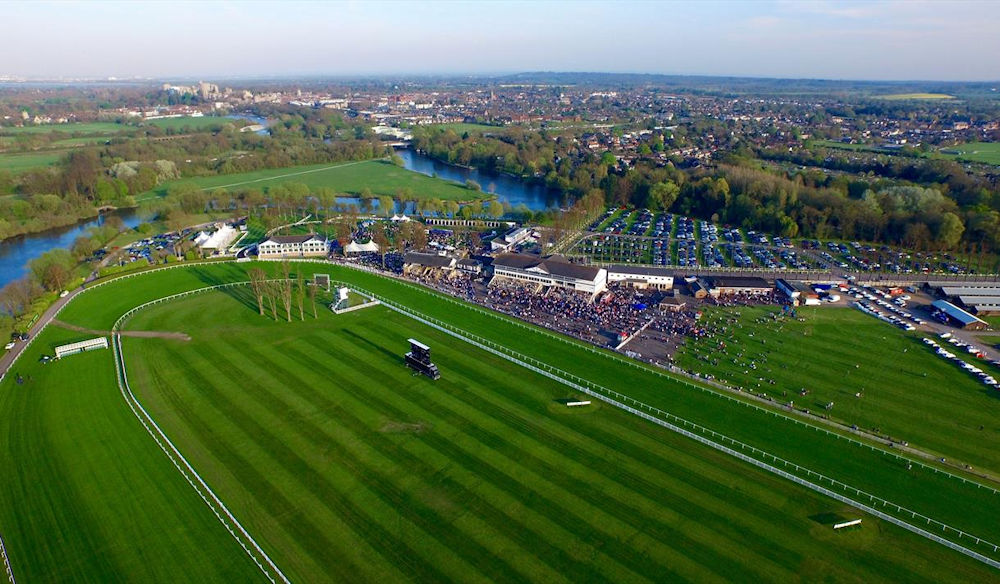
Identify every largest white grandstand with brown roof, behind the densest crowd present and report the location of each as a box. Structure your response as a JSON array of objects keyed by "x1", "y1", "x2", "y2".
[{"x1": 493, "y1": 253, "x2": 608, "y2": 294}]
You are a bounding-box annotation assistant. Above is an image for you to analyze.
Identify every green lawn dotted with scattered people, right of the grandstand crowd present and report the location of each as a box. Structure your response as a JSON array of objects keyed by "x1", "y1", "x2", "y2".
[{"x1": 676, "y1": 307, "x2": 1000, "y2": 474}]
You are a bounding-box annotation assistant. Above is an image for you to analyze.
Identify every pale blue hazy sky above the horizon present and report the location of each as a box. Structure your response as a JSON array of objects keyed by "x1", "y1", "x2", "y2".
[{"x1": 7, "y1": 0, "x2": 1000, "y2": 80}]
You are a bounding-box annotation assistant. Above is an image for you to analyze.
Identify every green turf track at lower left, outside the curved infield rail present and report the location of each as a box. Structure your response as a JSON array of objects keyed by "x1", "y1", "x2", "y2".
[{"x1": 0, "y1": 328, "x2": 263, "y2": 582}]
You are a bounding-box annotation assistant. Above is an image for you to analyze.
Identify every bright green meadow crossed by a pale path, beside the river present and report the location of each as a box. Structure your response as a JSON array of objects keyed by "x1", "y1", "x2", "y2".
[{"x1": 139, "y1": 160, "x2": 485, "y2": 201}]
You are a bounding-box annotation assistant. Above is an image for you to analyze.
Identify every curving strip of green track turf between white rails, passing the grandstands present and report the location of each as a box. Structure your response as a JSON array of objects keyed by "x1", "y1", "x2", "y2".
[{"x1": 50, "y1": 263, "x2": 1000, "y2": 551}]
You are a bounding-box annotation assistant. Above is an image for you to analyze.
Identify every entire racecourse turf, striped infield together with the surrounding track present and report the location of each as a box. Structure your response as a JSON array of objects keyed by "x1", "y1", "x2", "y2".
[{"x1": 0, "y1": 264, "x2": 1000, "y2": 582}]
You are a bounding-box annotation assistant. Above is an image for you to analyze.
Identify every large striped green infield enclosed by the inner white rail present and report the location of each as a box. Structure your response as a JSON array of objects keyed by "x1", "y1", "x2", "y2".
[{"x1": 113, "y1": 288, "x2": 1000, "y2": 582}]
